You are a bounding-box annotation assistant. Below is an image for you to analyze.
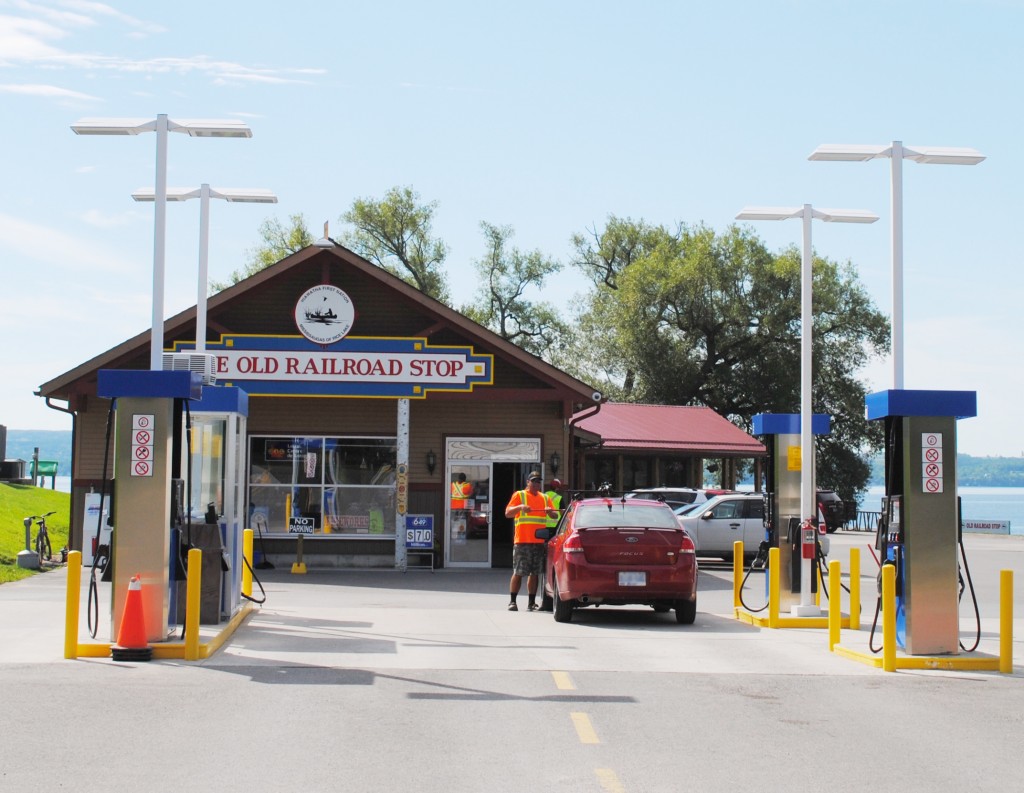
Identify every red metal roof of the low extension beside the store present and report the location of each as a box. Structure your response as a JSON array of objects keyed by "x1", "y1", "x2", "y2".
[{"x1": 578, "y1": 403, "x2": 766, "y2": 457}]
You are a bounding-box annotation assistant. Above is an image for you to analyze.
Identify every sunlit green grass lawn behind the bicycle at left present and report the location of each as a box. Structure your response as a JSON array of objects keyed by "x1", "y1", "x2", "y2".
[{"x1": 0, "y1": 483, "x2": 71, "y2": 584}]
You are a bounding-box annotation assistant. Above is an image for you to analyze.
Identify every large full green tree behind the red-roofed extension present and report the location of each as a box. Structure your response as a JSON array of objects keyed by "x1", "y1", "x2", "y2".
[{"x1": 581, "y1": 220, "x2": 888, "y2": 498}]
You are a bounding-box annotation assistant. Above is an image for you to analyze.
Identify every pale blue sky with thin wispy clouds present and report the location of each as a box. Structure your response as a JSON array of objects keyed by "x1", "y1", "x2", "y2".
[{"x1": 0, "y1": 0, "x2": 1024, "y2": 456}]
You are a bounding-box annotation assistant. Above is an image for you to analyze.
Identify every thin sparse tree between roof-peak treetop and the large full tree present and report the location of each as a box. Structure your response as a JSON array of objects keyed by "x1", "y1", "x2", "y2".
[{"x1": 462, "y1": 222, "x2": 566, "y2": 358}]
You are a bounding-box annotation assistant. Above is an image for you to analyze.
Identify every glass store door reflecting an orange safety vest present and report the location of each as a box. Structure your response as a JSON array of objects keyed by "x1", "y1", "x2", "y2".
[{"x1": 444, "y1": 462, "x2": 493, "y2": 568}]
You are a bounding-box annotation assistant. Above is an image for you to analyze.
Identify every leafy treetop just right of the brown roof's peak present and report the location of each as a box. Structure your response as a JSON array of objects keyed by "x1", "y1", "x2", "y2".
[{"x1": 341, "y1": 187, "x2": 451, "y2": 303}]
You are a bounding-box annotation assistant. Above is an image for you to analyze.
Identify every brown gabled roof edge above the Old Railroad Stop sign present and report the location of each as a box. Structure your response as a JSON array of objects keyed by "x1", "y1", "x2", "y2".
[{"x1": 38, "y1": 243, "x2": 594, "y2": 406}]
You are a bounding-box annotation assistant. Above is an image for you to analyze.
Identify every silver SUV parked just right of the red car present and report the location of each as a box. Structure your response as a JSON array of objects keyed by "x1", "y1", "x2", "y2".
[{"x1": 677, "y1": 493, "x2": 830, "y2": 561}]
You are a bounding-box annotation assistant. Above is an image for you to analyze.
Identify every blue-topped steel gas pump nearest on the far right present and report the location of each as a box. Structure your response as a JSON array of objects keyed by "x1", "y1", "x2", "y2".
[{"x1": 865, "y1": 389, "x2": 978, "y2": 655}]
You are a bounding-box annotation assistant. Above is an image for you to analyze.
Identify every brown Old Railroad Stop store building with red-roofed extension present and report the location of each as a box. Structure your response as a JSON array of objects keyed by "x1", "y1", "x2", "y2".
[{"x1": 38, "y1": 241, "x2": 764, "y2": 567}]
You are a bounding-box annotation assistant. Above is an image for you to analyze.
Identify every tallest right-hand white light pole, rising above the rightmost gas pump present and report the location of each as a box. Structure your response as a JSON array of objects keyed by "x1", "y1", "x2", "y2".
[{"x1": 807, "y1": 140, "x2": 985, "y2": 389}]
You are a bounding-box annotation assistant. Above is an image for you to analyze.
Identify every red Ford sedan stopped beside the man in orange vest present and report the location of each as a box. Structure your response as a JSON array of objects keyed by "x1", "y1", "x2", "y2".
[{"x1": 537, "y1": 497, "x2": 697, "y2": 625}]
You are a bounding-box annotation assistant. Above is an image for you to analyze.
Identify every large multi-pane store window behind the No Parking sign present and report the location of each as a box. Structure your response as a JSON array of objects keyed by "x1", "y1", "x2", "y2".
[{"x1": 249, "y1": 435, "x2": 396, "y2": 537}]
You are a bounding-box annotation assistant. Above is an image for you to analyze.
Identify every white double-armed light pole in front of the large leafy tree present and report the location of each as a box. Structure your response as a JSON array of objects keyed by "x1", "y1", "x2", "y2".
[{"x1": 736, "y1": 204, "x2": 879, "y2": 617}]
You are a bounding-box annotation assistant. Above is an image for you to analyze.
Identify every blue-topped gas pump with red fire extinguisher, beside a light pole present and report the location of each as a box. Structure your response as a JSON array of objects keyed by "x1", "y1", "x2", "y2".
[{"x1": 754, "y1": 413, "x2": 831, "y2": 610}]
